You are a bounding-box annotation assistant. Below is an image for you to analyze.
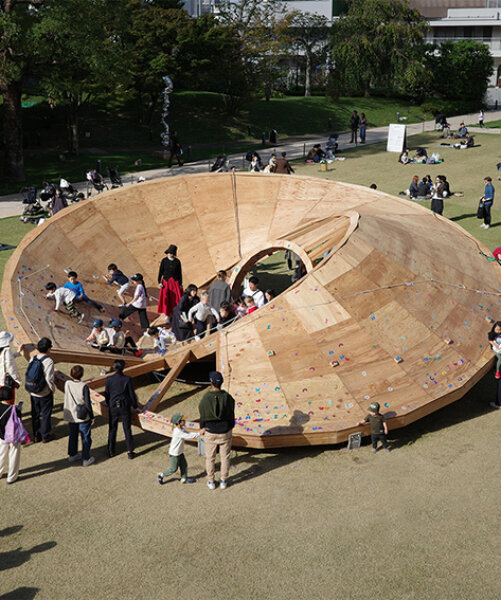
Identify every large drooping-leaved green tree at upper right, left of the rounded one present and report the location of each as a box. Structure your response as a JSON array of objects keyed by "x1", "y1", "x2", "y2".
[{"x1": 331, "y1": 0, "x2": 428, "y2": 96}]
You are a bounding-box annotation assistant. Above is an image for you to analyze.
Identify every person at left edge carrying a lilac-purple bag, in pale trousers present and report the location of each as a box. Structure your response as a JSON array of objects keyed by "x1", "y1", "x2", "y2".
[{"x1": 0, "y1": 400, "x2": 28, "y2": 484}]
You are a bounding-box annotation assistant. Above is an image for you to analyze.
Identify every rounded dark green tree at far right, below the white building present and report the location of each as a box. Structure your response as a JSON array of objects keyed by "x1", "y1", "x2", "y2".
[{"x1": 426, "y1": 40, "x2": 494, "y2": 103}]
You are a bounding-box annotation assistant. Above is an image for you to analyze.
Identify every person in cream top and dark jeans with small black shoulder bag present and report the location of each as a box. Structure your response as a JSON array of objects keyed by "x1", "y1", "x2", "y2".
[{"x1": 63, "y1": 365, "x2": 96, "y2": 467}]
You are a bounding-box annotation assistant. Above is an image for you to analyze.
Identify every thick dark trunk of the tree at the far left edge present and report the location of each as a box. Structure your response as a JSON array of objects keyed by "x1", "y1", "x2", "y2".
[{"x1": 0, "y1": 82, "x2": 25, "y2": 183}]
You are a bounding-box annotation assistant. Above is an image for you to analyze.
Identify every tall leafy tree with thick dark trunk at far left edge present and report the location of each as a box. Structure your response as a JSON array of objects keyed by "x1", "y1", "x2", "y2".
[{"x1": 0, "y1": 0, "x2": 44, "y2": 182}]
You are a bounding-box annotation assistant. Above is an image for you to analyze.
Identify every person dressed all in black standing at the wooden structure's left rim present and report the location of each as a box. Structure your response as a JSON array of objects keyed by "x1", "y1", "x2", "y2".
[{"x1": 104, "y1": 359, "x2": 138, "y2": 459}]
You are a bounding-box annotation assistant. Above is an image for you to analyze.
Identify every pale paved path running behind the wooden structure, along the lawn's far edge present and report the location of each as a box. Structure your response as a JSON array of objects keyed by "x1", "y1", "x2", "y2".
[{"x1": 0, "y1": 111, "x2": 501, "y2": 218}]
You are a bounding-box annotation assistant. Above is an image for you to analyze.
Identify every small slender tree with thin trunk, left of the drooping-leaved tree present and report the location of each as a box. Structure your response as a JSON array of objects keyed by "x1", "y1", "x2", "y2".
[{"x1": 288, "y1": 11, "x2": 329, "y2": 96}]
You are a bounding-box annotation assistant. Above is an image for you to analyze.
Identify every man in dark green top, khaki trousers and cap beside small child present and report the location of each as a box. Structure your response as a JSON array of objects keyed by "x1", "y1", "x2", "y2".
[{"x1": 198, "y1": 371, "x2": 235, "y2": 490}]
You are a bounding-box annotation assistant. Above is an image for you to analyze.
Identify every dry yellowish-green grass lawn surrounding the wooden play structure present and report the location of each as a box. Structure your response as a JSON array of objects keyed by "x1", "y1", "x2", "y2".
[{"x1": 4, "y1": 134, "x2": 501, "y2": 600}]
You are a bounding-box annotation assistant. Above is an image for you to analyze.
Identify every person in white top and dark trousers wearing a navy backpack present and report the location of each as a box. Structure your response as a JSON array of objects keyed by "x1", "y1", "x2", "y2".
[{"x1": 24, "y1": 337, "x2": 56, "y2": 444}]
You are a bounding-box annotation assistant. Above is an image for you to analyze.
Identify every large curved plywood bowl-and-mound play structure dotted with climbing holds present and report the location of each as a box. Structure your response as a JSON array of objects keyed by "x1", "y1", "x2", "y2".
[{"x1": 2, "y1": 174, "x2": 501, "y2": 447}]
